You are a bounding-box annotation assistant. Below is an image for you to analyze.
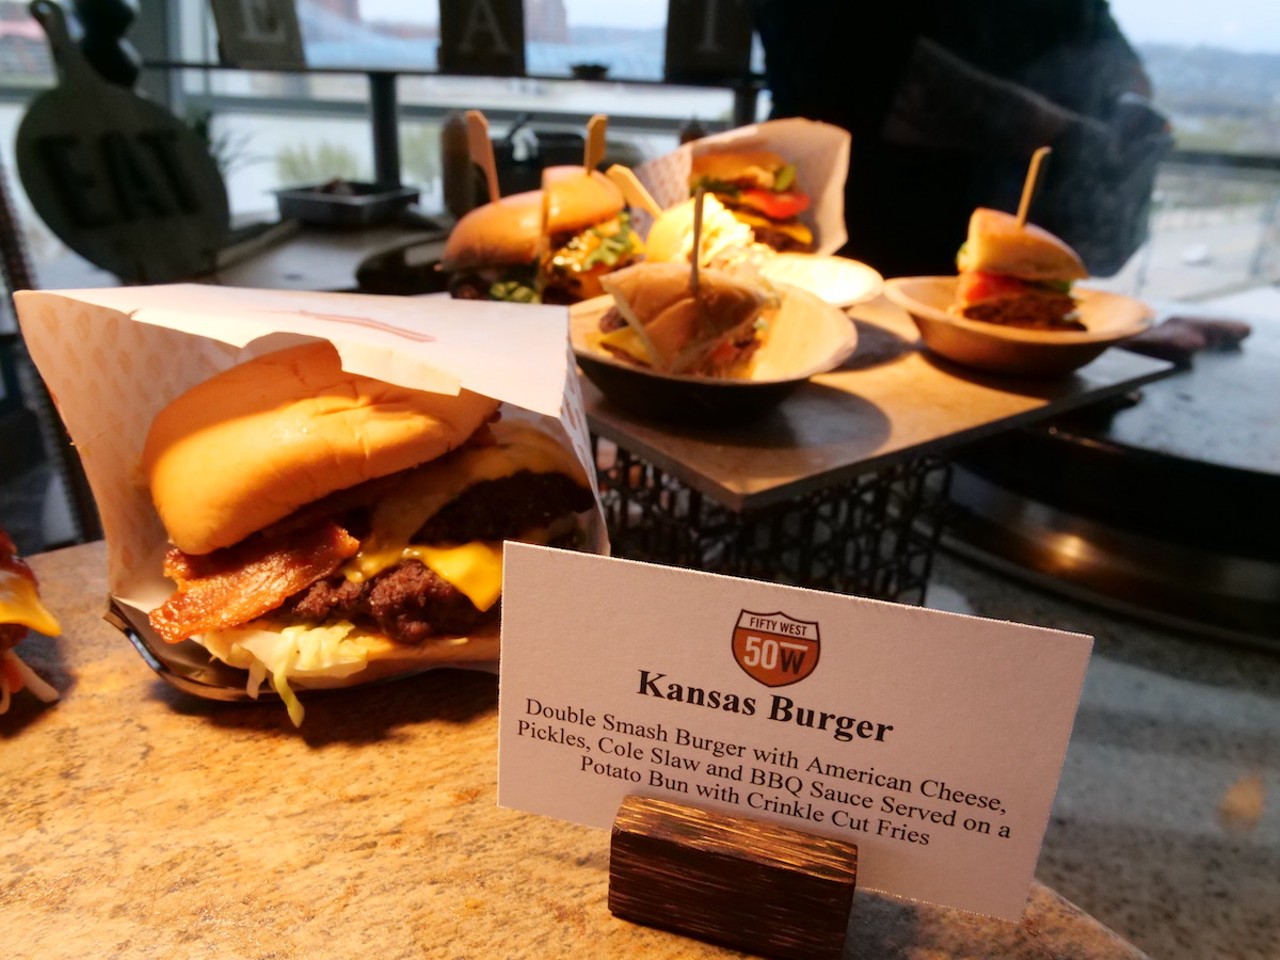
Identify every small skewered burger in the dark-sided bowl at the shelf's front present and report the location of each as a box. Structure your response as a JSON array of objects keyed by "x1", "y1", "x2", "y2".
[{"x1": 596, "y1": 264, "x2": 777, "y2": 376}]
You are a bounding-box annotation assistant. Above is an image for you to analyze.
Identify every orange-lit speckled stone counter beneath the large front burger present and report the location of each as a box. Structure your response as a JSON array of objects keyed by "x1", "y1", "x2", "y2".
[{"x1": 0, "y1": 544, "x2": 1152, "y2": 960}]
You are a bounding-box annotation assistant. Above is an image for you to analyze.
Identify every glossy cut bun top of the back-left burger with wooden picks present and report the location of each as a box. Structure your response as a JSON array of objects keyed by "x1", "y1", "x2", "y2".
[{"x1": 442, "y1": 166, "x2": 626, "y2": 270}]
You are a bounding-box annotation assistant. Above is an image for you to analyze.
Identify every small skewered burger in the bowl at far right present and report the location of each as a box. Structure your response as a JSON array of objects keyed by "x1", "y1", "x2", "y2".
[{"x1": 952, "y1": 207, "x2": 1089, "y2": 330}]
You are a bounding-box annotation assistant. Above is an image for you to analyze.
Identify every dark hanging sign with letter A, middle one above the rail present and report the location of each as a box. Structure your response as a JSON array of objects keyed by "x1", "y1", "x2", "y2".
[{"x1": 439, "y1": 0, "x2": 525, "y2": 77}]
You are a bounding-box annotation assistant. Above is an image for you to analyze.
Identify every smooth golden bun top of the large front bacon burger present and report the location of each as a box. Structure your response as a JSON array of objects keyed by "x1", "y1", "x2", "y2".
[{"x1": 142, "y1": 343, "x2": 498, "y2": 554}]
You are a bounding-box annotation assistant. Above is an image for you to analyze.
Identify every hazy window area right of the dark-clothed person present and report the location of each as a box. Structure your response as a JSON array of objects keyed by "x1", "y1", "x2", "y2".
[{"x1": 1111, "y1": 0, "x2": 1280, "y2": 302}]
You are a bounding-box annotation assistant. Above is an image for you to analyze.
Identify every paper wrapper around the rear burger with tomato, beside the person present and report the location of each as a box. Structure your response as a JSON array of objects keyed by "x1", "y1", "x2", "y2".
[{"x1": 635, "y1": 118, "x2": 851, "y2": 255}]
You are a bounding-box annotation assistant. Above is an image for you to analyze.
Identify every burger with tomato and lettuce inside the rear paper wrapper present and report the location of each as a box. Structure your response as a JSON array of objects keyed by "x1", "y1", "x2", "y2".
[{"x1": 689, "y1": 150, "x2": 813, "y2": 252}]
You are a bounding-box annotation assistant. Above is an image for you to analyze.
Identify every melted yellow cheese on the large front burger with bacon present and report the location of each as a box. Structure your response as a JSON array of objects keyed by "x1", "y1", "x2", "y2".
[{"x1": 342, "y1": 421, "x2": 586, "y2": 611}]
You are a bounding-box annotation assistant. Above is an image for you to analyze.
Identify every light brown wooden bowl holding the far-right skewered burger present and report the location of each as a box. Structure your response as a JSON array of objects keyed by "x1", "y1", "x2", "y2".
[{"x1": 884, "y1": 276, "x2": 1155, "y2": 378}]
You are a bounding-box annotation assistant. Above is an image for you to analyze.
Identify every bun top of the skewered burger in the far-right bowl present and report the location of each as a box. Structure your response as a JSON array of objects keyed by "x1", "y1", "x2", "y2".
[{"x1": 956, "y1": 207, "x2": 1089, "y2": 280}]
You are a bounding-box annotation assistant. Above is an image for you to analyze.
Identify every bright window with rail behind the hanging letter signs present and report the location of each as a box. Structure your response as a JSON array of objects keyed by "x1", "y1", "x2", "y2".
[{"x1": 178, "y1": 0, "x2": 735, "y2": 214}]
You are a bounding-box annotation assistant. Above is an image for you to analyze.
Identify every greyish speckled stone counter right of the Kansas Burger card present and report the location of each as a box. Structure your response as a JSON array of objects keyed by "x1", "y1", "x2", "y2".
[{"x1": 928, "y1": 553, "x2": 1280, "y2": 960}]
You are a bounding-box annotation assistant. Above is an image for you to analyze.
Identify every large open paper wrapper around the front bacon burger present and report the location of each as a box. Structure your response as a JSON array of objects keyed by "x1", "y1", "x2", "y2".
[{"x1": 14, "y1": 284, "x2": 608, "y2": 660}]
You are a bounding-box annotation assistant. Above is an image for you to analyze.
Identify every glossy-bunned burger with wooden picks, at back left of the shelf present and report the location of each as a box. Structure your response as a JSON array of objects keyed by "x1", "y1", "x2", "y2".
[{"x1": 440, "y1": 166, "x2": 644, "y2": 303}]
